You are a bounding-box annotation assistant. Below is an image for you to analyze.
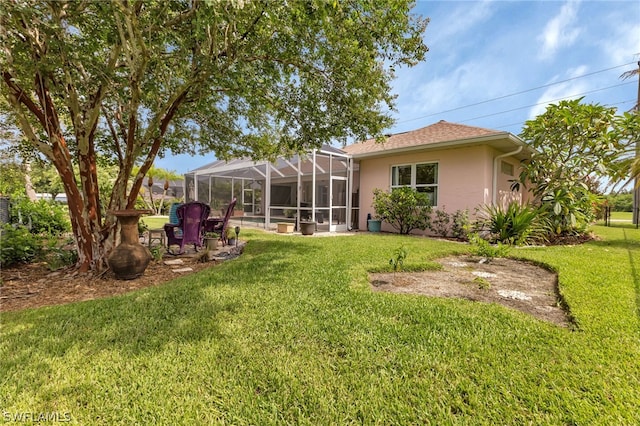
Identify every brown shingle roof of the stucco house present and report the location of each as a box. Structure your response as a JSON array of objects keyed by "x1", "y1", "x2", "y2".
[{"x1": 343, "y1": 120, "x2": 507, "y2": 156}]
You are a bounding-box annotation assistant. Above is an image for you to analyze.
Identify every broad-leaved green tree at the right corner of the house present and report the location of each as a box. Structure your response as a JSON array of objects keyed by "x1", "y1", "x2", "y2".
[{"x1": 515, "y1": 98, "x2": 640, "y2": 234}]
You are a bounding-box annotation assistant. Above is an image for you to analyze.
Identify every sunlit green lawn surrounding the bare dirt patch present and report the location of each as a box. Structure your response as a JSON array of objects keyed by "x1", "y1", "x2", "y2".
[{"x1": 0, "y1": 227, "x2": 640, "y2": 425}]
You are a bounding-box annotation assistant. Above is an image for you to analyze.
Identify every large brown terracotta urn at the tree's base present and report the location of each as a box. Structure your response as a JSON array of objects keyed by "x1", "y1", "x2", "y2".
[{"x1": 107, "y1": 209, "x2": 151, "y2": 280}]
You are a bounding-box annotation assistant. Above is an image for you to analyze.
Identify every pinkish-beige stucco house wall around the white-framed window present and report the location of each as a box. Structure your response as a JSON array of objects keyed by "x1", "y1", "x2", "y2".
[{"x1": 359, "y1": 145, "x2": 519, "y2": 232}]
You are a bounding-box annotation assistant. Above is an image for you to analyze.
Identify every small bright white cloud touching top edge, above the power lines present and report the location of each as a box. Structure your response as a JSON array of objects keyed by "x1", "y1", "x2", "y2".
[{"x1": 538, "y1": 0, "x2": 580, "y2": 59}]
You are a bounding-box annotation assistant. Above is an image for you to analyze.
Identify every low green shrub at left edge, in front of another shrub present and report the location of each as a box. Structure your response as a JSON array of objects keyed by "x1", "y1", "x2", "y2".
[{"x1": 0, "y1": 225, "x2": 44, "y2": 268}]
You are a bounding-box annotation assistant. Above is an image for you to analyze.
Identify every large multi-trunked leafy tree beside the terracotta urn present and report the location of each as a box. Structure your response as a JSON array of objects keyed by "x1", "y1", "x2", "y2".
[{"x1": 0, "y1": 0, "x2": 427, "y2": 269}]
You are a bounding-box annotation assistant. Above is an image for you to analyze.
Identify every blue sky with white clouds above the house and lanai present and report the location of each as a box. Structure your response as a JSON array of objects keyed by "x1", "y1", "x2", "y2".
[{"x1": 156, "y1": 0, "x2": 640, "y2": 173}]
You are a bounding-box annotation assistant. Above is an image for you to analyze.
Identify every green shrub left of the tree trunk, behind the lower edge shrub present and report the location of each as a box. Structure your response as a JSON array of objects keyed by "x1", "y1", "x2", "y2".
[{"x1": 9, "y1": 198, "x2": 71, "y2": 235}]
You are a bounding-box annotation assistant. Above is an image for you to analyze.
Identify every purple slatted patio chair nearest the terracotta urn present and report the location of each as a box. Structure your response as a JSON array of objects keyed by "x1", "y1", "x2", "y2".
[{"x1": 164, "y1": 201, "x2": 211, "y2": 254}]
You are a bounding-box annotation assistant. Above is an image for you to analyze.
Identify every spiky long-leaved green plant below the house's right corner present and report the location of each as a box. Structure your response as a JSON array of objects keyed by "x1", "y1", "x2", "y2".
[{"x1": 476, "y1": 201, "x2": 549, "y2": 245}]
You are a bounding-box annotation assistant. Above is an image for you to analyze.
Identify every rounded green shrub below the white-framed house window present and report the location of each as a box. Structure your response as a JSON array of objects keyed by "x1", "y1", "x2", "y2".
[{"x1": 373, "y1": 187, "x2": 431, "y2": 234}]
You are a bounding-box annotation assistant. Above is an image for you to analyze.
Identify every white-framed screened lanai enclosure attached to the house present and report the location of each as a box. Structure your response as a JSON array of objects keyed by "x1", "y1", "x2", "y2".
[{"x1": 185, "y1": 146, "x2": 359, "y2": 232}]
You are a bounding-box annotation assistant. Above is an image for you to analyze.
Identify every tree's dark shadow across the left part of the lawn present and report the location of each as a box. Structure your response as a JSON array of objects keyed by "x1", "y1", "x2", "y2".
[{"x1": 0, "y1": 239, "x2": 319, "y2": 370}]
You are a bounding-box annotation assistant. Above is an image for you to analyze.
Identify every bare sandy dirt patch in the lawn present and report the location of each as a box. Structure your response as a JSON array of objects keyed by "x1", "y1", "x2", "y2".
[{"x1": 369, "y1": 256, "x2": 572, "y2": 327}]
